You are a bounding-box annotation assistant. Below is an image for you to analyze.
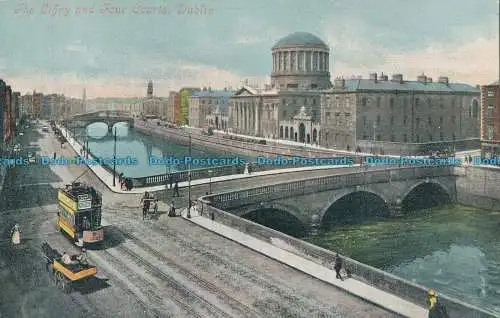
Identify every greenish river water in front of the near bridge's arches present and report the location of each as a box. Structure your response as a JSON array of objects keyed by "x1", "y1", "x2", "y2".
[{"x1": 305, "y1": 205, "x2": 500, "y2": 315}]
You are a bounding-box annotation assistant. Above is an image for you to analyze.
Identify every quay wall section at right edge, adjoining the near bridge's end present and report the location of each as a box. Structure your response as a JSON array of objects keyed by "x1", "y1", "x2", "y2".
[{"x1": 455, "y1": 166, "x2": 500, "y2": 211}]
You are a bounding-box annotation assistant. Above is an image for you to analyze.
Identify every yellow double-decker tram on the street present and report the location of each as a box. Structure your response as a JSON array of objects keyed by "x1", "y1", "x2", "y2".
[{"x1": 56, "y1": 182, "x2": 104, "y2": 247}]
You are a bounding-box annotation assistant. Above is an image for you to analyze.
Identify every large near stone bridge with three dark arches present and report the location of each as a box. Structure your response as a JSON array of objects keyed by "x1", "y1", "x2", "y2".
[{"x1": 204, "y1": 166, "x2": 458, "y2": 234}]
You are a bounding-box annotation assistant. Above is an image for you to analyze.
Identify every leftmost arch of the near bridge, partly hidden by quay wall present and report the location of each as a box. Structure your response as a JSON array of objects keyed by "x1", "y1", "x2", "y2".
[{"x1": 237, "y1": 202, "x2": 310, "y2": 236}]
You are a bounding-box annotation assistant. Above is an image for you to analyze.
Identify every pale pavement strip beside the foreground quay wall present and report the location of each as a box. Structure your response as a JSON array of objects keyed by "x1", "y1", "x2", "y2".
[{"x1": 182, "y1": 208, "x2": 428, "y2": 318}]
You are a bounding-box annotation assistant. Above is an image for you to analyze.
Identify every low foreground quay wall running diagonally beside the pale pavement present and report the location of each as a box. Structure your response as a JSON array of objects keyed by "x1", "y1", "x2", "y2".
[{"x1": 198, "y1": 198, "x2": 496, "y2": 318}]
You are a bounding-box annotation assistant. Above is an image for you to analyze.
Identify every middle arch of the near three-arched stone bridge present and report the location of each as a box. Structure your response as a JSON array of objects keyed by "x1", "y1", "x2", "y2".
[{"x1": 319, "y1": 186, "x2": 390, "y2": 227}]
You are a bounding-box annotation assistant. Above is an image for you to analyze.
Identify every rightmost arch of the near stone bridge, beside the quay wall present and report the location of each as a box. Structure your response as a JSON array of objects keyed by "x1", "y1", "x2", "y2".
[{"x1": 401, "y1": 179, "x2": 452, "y2": 211}]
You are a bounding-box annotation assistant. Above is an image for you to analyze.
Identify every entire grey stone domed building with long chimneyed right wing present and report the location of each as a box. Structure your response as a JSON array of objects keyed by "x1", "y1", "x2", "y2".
[{"x1": 228, "y1": 32, "x2": 480, "y2": 153}]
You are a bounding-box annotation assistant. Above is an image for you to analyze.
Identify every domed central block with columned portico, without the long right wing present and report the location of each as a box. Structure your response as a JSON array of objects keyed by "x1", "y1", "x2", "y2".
[{"x1": 229, "y1": 32, "x2": 332, "y2": 143}]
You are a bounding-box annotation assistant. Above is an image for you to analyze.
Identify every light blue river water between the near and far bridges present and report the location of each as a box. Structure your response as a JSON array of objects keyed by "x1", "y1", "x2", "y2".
[{"x1": 75, "y1": 123, "x2": 247, "y2": 178}]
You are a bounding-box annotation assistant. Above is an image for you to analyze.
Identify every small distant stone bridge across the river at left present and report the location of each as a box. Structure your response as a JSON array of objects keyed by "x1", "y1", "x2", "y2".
[{"x1": 66, "y1": 111, "x2": 134, "y2": 133}]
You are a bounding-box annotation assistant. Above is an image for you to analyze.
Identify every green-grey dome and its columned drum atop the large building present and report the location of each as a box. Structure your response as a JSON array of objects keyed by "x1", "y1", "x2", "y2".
[{"x1": 271, "y1": 32, "x2": 332, "y2": 90}]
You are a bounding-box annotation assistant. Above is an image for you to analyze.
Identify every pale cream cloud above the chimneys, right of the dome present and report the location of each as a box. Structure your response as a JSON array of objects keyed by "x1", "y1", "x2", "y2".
[{"x1": 331, "y1": 35, "x2": 499, "y2": 85}]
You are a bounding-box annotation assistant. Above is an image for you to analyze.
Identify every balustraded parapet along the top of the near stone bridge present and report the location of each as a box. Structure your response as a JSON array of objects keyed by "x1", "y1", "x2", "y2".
[{"x1": 207, "y1": 166, "x2": 458, "y2": 209}]
